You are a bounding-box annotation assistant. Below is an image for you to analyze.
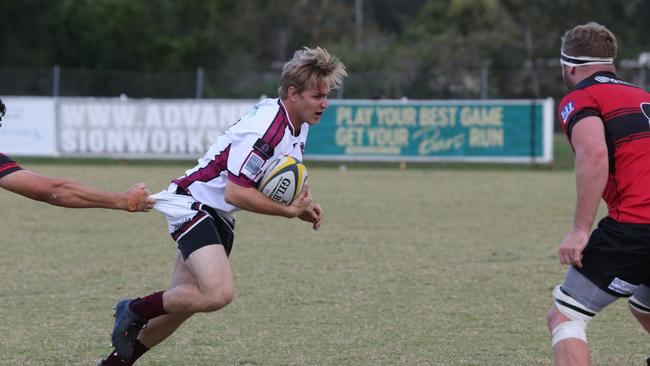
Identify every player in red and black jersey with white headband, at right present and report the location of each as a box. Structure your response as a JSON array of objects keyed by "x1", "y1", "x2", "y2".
[{"x1": 548, "y1": 22, "x2": 650, "y2": 366}]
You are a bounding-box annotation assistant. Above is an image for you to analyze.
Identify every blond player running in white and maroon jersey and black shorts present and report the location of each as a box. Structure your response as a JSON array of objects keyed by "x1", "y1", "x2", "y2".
[{"x1": 100, "y1": 47, "x2": 347, "y2": 366}]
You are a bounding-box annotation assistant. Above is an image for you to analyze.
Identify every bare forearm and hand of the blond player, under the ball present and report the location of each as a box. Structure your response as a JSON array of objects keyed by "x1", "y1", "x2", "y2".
[{"x1": 225, "y1": 181, "x2": 311, "y2": 218}]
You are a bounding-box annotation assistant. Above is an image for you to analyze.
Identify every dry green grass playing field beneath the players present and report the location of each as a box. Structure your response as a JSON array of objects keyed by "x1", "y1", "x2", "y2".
[{"x1": 0, "y1": 154, "x2": 650, "y2": 366}]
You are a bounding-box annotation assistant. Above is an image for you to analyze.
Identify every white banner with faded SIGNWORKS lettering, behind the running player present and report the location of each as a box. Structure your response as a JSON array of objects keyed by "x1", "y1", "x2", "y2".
[{"x1": 57, "y1": 98, "x2": 256, "y2": 159}]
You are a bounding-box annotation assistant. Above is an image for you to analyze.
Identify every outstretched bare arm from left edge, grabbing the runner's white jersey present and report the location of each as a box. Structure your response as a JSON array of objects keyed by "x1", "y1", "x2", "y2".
[{"x1": 0, "y1": 170, "x2": 155, "y2": 212}]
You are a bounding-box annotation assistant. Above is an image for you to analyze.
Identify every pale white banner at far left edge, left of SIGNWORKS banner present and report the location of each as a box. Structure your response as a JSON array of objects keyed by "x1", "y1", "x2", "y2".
[{"x1": 0, "y1": 97, "x2": 57, "y2": 156}]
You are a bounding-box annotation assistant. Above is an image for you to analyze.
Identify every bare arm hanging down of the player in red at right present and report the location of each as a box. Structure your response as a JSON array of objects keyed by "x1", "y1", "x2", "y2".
[{"x1": 558, "y1": 117, "x2": 609, "y2": 267}]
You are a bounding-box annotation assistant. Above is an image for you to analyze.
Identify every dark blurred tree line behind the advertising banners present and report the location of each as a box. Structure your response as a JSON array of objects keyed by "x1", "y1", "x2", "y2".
[{"x1": 0, "y1": 0, "x2": 650, "y2": 98}]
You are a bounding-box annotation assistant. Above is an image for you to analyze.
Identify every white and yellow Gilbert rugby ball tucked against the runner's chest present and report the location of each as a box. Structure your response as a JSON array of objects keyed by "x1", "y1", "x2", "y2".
[{"x1": 257, "y1": 156, "x2": 307, "y2": 205}]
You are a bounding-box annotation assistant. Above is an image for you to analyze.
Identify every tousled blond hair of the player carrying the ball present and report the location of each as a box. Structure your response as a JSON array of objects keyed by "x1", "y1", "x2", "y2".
[{"x1": 278, "y1": 47, "x2": 348, "y2": 99}]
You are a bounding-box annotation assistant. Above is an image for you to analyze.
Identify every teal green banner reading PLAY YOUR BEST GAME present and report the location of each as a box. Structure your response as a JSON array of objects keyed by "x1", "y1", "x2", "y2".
[{"x1": 305, "y1": 98, "x2": 553, "y2": 163}]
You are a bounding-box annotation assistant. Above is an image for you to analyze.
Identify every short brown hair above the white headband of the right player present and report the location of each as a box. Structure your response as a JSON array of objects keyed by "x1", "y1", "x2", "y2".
[{"x1": 562, "y1": 22, "x2": 618, "y2": 58}]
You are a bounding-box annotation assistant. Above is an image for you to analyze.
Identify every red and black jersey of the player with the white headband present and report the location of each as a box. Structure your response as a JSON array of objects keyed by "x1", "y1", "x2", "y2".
[{"x1": 559, "y1": 72, "x2": 650, "y2": 224}]
